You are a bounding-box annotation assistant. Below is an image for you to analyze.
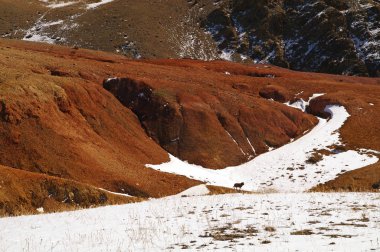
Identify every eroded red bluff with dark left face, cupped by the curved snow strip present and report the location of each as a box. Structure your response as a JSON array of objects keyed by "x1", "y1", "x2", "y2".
[{"x1": 103, "y1": 78, "x2": 317, "y2": 169}]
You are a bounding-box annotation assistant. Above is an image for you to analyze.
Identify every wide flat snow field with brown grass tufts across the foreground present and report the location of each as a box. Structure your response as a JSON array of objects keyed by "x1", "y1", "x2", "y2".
[{"x1": 0, "y1": 192, "x2": 380, "y2": 252}]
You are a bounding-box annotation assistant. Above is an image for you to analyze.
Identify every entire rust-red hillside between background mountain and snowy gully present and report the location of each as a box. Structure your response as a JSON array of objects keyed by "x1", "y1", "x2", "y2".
[{"x1": 0, "y1": 40, "x2": 380, "y2": 215}]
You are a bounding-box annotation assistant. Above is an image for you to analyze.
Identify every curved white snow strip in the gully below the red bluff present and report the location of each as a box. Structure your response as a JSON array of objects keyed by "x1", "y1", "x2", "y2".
[{"x1": 146, "y1": 105, "x2": 379, "y2": 192}]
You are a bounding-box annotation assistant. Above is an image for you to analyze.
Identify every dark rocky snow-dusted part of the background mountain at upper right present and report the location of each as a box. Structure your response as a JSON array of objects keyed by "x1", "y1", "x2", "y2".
[{"x1": 202, "y1": 0, "x2": 380, "y2": 76}]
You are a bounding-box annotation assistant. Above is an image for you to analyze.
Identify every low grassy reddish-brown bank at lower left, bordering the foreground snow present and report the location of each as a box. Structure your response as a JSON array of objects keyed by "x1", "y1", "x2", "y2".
[{"x1": 0, "y1": 165, "x2": 141, "y2": 216}]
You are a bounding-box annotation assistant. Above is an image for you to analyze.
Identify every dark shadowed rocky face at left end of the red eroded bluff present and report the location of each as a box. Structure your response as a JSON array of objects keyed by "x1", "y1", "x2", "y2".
[{"x1": 103, "y1": 78, "x2": 183, "y2": 156}]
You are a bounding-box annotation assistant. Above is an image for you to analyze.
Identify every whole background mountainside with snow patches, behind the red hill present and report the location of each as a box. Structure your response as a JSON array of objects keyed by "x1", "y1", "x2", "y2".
[{"x1": 0, "y1": 0, "x2": 380, "y2": 76}]
